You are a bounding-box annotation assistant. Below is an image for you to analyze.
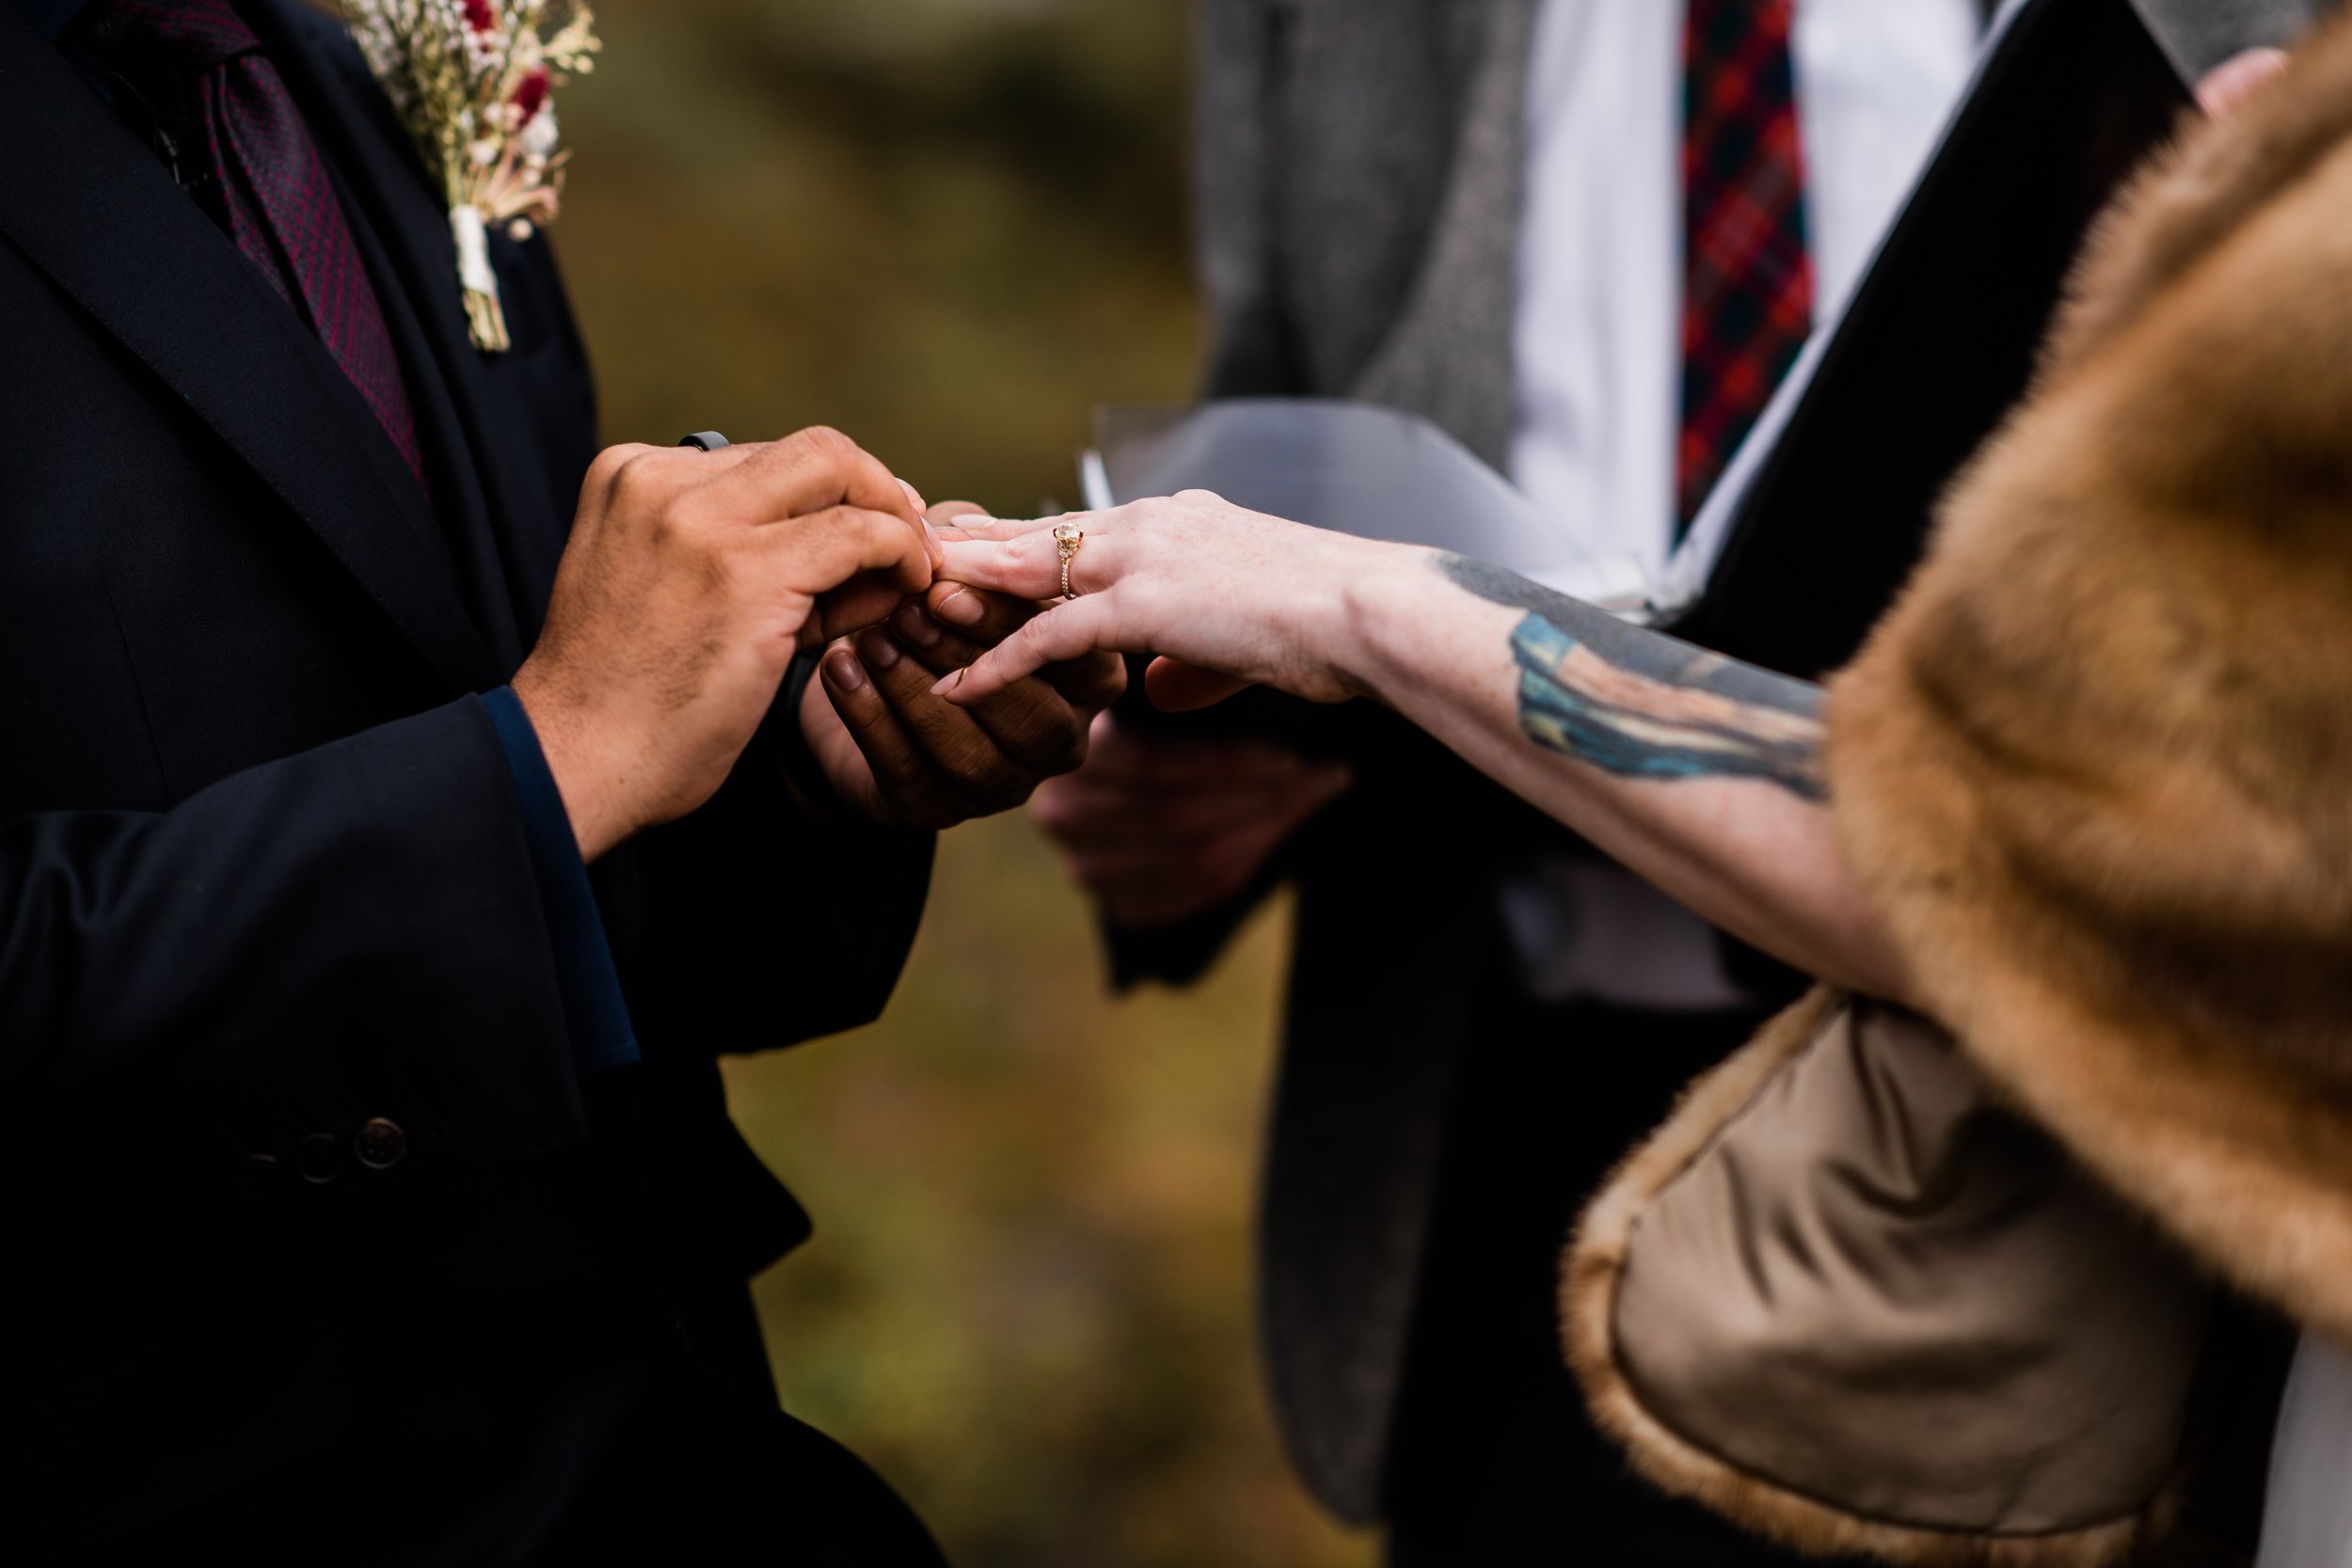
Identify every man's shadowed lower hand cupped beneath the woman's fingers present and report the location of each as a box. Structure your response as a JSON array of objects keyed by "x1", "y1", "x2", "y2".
[{"x1": 803, "y1": 503, "x2": 1127, "y2": 828}]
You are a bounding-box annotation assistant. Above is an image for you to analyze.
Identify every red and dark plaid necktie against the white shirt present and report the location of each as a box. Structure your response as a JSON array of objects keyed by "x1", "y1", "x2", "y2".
[{"x1": 1675, "y1": 0, "x2": 1814, "y2": 527}]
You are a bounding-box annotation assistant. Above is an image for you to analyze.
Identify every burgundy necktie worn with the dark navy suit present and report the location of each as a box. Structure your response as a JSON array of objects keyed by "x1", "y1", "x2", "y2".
[{"x1": 83, "y1": 0, "x2": 426, "y2": 484}]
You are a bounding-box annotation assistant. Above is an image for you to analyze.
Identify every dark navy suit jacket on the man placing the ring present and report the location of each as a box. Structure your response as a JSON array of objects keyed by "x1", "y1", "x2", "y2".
[{"x1": 0, "y1": 0, "x2": 931, "y2": 1557}]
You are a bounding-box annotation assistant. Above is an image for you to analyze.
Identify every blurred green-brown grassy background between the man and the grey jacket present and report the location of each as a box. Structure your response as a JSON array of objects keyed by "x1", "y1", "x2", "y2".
[{"x1": 555, "y1": 0, "x2": 1372, "y2": 1568}]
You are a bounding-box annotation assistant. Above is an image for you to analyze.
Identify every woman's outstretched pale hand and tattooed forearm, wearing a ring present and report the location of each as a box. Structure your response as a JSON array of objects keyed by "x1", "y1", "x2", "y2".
[{"x1": 934, "y1": 494, "x2": 1905, "y2": 997}]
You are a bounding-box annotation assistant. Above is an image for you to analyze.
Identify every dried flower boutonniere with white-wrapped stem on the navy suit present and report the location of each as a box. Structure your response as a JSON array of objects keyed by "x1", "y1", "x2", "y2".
[{"x1": 343, "y1": 0, "x2": 597, "y2": 353}]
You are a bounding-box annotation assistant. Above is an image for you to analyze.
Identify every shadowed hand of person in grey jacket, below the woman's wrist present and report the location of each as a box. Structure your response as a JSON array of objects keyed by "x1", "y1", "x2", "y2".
[{"x1": 1035, "y1": 715, "x2": 1350, "y2": 931}]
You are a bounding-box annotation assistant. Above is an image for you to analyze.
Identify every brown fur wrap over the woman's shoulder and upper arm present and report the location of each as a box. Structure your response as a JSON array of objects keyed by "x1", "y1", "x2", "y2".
[{"x1": 1830, "y1": 6, "x2": 2352, "y2": 1342}]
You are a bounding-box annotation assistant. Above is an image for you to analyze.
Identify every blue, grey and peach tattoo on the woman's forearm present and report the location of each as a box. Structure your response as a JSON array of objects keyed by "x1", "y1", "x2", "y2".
[{"x1": 1438, "y1": 555, "x2": 1828, "y2": 801}]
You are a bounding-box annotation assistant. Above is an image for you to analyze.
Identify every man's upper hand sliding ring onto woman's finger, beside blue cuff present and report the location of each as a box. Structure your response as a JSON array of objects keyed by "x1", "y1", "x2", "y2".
[{"x1": 516, "y1": 430, "x2": 936, "y2": 861}]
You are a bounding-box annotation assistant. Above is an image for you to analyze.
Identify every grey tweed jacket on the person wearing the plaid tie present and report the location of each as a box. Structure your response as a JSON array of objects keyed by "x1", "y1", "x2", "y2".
[{"x1": 1185, "y1": 0, "x2": 2317, "y2": 1519}]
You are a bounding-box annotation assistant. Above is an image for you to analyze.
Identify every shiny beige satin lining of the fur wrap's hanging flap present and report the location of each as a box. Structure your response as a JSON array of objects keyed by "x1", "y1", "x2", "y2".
[{"x1": 1616, "y1": 1004, "x2": 2206, "y2": 1535}]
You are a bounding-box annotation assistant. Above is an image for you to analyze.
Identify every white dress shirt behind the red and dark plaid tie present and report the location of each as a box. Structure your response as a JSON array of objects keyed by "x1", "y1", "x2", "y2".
[{"x1": 1503, "y1": 0, "x2": 1980, "y2": 1008}]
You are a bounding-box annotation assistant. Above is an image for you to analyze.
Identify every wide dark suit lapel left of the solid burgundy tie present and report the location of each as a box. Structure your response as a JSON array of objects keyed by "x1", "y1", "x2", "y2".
[{"x1": 0, "y1": 5, "x2": 503, "y2": 691}]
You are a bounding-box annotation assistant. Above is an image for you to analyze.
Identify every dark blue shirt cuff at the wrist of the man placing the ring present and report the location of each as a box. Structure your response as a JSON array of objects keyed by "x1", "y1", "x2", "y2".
[{"x1": 483, "y1": 687, "x2": 643, "y2": 1077}]
